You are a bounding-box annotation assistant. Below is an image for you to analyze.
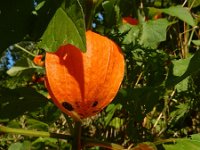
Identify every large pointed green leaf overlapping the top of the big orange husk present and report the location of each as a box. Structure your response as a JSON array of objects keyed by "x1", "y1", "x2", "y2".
[{"x1": 39, "y1": 0, "x2": 86, "y2": 52}]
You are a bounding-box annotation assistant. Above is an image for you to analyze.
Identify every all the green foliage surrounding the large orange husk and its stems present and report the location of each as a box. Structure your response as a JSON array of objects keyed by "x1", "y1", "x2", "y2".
[{"x1": 0, "y1": 0, "x2": 200, "y2": 150}]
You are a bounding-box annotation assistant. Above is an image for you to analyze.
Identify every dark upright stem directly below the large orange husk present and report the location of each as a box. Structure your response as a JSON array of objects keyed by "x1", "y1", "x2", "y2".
[{"x1": 72, "y1": 121, "x2": 82, "y2": 150}]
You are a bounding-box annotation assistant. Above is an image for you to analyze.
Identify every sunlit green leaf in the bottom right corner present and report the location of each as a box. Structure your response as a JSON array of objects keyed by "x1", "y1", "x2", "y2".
[{"x1": 163, "y1": 134, "x2": 200, "y2": 150}]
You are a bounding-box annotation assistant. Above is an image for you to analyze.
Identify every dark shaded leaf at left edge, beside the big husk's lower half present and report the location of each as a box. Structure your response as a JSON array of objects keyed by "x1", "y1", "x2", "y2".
[{"x1": 0, "y1": 88, "x2": 48, "y2": 119}]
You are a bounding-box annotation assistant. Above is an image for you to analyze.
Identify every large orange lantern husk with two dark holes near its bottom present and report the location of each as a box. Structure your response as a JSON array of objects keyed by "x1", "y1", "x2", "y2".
[{"x1": 45, "y1": 31, "x2": 125, "y2": 120}]
